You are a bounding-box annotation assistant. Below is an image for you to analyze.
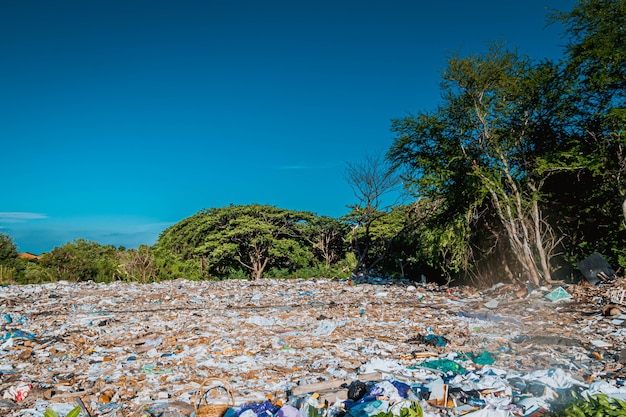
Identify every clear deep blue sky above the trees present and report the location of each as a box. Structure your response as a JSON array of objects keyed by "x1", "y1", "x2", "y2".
[{"x1": 0, "y1": 0, "x2": 574, "y2": 253}]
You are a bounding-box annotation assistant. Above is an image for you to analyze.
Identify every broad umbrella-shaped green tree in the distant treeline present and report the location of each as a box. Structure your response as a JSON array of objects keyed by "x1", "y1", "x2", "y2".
[{"x1": 157, "y1": 204, "x2": 314, "y2": 279}]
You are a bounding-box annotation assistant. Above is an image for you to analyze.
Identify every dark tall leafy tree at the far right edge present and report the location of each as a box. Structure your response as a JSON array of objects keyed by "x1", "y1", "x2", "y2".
[{"x1": 542, "y1": 0, "x2": 626, "y2": 264}]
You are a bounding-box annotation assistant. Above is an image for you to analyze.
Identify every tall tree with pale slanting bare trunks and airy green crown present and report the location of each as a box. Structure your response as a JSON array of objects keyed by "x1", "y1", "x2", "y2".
[{"x1": 389, "y1": 45, "x2": 558, "y2": 285}]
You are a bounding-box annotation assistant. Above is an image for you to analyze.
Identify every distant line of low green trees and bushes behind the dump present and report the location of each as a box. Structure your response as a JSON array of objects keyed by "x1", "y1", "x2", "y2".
[{"x1": 0, "y1": 204, "x2": 436, "y2": 284}]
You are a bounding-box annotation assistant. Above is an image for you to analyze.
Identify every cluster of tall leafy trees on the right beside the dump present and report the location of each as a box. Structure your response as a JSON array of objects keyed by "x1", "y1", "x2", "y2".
[{"x1": 389, "y1": 0, "x2": 626, "y2": 283}]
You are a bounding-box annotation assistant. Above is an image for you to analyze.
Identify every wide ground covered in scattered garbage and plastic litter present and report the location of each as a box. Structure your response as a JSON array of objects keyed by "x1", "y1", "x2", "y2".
[{"x1": 0, "y1": 278, "x2": 626, "y2": 417}]
